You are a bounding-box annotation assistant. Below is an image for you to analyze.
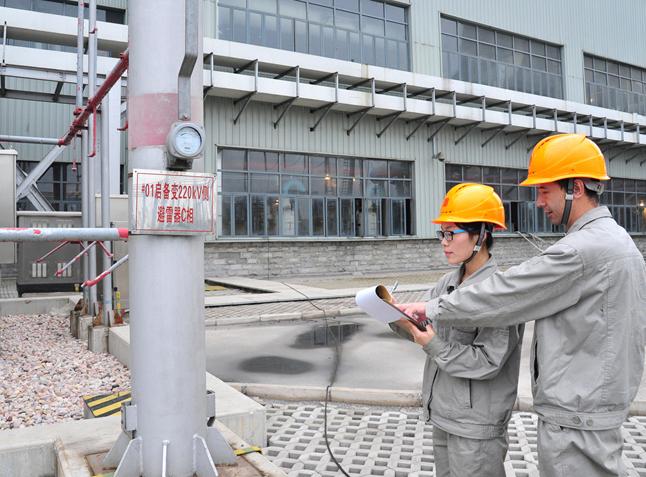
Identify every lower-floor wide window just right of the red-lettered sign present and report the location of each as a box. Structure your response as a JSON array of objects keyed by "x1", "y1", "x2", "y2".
[{"x1": 220, "y1": 149, "x2": 413, "y2": 237}]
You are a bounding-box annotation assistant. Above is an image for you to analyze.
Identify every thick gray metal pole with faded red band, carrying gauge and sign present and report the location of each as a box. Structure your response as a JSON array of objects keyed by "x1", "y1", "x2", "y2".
[{"x1": 109, "y1": 0, "x2": 235, "y2": 477}]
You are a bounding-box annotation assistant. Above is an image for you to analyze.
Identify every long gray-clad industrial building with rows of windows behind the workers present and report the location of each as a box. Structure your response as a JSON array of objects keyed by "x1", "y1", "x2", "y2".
[{"x1": 0, "y1": 0, "x2": 646, "y2": 276}]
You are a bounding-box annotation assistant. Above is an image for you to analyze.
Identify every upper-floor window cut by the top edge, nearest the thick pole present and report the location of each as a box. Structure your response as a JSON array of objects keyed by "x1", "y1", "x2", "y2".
[{"x1": 218, "y1": 0, "x2": 410, "y2": 70}]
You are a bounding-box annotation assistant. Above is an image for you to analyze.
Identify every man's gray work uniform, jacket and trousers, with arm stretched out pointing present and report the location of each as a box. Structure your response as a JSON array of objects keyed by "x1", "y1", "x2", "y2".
[{"x1": 426, "y1": 207, "x2": 646, "y2": 477}]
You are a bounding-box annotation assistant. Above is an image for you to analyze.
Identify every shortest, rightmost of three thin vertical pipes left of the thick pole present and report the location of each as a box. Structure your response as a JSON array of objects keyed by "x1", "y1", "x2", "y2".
[{"x1": 101, "y1": 97, "x2": 112, "y2": 326}]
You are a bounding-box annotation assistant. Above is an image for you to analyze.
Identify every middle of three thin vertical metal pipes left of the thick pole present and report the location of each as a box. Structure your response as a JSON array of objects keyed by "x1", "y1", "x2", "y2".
[{"x1": 85, "y1": 0, "x2": 97, "y2": 315}]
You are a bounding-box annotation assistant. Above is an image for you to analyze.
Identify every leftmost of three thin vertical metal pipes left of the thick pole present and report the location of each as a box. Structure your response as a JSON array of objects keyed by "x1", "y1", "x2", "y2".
[{"x1": 78, "y1": 0, "x2": 90, "y2": 309}]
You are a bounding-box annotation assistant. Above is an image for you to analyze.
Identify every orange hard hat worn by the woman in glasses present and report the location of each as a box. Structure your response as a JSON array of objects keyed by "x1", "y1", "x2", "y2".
[{"x1": 433, "y1": 182, "x2": 507, "y2": 229}]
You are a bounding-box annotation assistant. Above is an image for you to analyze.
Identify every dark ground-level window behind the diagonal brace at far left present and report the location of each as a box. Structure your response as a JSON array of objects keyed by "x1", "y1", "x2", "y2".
[{"x1": 16, "y1": 161, "x2": 81, "y2": 212}]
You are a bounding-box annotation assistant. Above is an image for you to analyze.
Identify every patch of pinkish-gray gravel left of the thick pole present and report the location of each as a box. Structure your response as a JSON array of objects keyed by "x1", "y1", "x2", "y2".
[{"x1": 0, "y1": 314, "x2": 130, "y2": 429}]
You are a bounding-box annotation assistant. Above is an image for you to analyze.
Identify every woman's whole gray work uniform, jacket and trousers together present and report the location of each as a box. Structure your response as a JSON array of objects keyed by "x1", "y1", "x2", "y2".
[{"x1": 391, "y1": 258, "x2": 524, "y2": 477}]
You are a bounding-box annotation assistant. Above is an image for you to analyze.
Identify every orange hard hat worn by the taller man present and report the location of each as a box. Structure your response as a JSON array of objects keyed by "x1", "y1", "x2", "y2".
[{"x1": 520, "y1": 134, "x2": 610, "y2": 186}]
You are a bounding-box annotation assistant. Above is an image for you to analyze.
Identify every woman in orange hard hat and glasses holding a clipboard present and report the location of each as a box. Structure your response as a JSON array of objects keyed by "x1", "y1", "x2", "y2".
[{"x1": 391, "y1": 183, "x2": 523, "y2": 477}]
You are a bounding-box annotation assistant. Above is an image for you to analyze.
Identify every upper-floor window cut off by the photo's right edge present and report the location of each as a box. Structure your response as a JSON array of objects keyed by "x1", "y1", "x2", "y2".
[{"x1": 583, "y1": 55, "x2": 646, "y2": 114}]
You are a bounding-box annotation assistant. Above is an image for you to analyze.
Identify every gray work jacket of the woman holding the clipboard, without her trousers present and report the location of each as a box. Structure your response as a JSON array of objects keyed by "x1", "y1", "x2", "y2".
[{"x1": 391, "y1": 258, "x2": 524, "y2": 439}]
